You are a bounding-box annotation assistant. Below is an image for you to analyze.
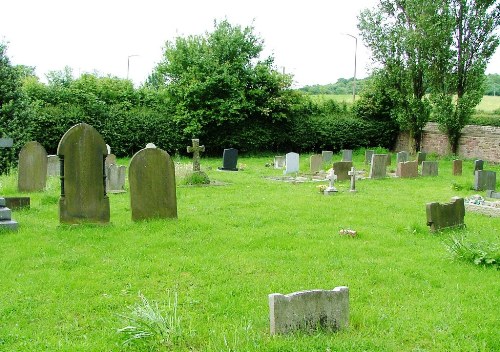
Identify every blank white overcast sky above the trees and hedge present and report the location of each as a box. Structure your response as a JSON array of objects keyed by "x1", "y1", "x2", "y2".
[{"x1": 0, "y1": 0, "x2": 500, "y2": 87}]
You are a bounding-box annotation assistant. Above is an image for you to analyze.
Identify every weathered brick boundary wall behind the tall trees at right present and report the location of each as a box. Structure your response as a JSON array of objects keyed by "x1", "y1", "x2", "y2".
[{"x1": 395, "y1": 122, "x2": 500, "y2": 162}]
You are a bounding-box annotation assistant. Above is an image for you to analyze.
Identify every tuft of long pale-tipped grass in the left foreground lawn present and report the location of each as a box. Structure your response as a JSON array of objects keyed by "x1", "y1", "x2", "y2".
[{"x1": 118, "y1": 293, "x2": 182, "y2": 347}]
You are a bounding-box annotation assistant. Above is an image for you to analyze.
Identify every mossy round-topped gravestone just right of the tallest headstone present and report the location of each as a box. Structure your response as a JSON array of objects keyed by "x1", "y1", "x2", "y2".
[{"x1": 128, "y1": 148, "x2": 177, "y2": 221}]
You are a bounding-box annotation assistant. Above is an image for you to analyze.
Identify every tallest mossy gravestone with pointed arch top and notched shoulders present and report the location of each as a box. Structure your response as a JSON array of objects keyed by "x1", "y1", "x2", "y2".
[{"x1": 57, "y1": 123, "x2": 109, "y2": 224}]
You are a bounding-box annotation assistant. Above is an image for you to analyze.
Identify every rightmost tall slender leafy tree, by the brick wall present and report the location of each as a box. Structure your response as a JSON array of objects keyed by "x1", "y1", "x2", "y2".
[{"x1": 431, "y1": 0, "x2": 500, "y2": 153}]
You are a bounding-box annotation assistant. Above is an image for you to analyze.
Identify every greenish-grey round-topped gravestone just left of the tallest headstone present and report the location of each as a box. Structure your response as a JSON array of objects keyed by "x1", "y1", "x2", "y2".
[{"x1": 17, "y1": 141, "x2": 47, "y2": 192}]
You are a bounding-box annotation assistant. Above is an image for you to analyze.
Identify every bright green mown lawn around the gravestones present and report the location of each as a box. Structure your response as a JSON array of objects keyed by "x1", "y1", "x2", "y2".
[{"x1": 0, "y1": 152, "x2": 500, "y2": 351}]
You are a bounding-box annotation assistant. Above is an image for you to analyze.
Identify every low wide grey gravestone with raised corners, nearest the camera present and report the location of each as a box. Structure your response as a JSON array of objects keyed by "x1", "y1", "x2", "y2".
[{"x1": 269, "y1": 286, "x2": 349, "y2": 335}]
